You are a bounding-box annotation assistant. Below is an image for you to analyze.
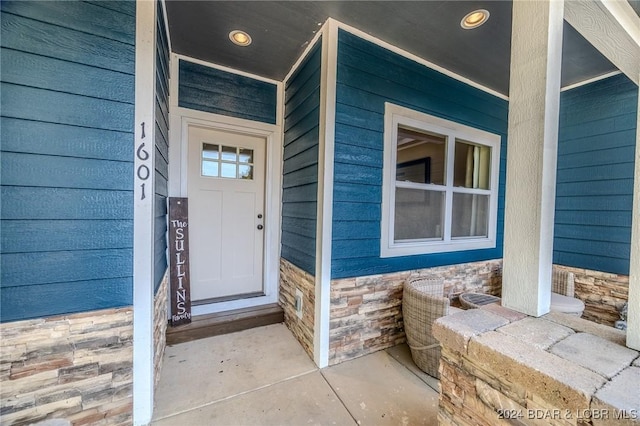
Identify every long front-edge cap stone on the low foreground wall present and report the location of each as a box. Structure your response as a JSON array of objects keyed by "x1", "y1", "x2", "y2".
[{"x1": 467, "y1": 331, "x2": 606, "y2": 411}]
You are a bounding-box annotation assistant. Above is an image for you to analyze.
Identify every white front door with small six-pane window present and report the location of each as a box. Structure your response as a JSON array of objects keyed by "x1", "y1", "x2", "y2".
[{"x1": 188, "y1": 125, "x2": 266, "y2": 305}]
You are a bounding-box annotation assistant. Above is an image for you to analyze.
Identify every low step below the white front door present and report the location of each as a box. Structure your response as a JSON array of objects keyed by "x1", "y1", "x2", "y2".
[{"x1": 167, "y1": 303, "x2": 284, "y2": 345}]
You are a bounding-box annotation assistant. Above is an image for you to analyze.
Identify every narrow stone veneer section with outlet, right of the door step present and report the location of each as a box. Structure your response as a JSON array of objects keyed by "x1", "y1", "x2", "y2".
[{"x1": 278, "y1": 258, "x2": 316, "y2": 359}]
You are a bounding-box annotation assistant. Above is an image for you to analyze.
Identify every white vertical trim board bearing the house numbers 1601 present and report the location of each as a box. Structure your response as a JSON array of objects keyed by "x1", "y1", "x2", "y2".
[{"x1": 133, "y1": 1, "x2": 156, "y2": 425}]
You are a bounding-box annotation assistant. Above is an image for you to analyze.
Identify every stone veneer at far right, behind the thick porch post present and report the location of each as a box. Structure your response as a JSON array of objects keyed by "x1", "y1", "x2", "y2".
[{"x1": 554, "y1": 265, "x2": 629, "y2": 327}]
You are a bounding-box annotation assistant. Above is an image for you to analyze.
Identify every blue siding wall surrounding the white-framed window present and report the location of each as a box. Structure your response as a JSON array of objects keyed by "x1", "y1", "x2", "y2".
[{"x1": 331, "y1": 30, "x2": 508, "y2": 279}]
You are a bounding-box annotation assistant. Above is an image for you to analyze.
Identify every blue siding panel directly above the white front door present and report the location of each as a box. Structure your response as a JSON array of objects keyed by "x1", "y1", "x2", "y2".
[{"x1": 178, "y1": 60, "x2": 277, "y2": 124}]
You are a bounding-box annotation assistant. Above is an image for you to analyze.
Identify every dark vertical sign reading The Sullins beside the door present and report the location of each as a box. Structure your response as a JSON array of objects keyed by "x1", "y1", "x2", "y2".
[{"x1": 169, "y1": 197, "x2": 191, "y2": 326}]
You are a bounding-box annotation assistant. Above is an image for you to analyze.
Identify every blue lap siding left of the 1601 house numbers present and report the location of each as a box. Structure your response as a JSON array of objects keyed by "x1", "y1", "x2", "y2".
[{"x1": 0, "y1": 1, "x2": 135, "y2": 322}]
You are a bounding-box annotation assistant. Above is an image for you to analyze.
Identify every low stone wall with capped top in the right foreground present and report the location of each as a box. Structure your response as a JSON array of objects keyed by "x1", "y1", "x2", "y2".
[{"x1": 433, "y1": 304, "x2": 640, "y2": 425}]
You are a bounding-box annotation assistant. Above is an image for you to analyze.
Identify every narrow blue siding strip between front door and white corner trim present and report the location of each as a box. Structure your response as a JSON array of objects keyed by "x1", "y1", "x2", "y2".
[{"x1": 281, "y1": 42, "x2": 321, "y2": 275}]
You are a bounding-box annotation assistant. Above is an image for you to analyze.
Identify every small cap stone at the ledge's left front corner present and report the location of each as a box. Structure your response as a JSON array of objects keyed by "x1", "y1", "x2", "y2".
[{"x1": 432, "y1": 309, "x2": 509, "y2": 354}]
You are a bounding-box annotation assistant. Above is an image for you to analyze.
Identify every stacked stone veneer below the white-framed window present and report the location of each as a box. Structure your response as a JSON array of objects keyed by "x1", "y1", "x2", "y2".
[{"x1": 329, "y1": 259, "x2": 502, "y2": 364}]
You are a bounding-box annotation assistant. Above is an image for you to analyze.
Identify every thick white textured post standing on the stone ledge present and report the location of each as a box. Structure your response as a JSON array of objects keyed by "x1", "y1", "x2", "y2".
[{"x1": 502, "y1": 0, "x2": 564, "y2": 316}]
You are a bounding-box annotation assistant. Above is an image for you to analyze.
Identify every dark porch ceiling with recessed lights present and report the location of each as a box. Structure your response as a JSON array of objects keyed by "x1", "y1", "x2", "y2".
[{"x1": 166, "y1": 0, "x2": 640, "y2": 95}]
